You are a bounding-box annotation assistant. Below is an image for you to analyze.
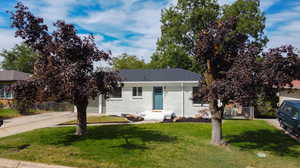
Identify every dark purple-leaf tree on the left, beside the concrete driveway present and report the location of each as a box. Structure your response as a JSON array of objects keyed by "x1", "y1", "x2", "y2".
[{"x1": 10, "y1": 3, "x2": 120, "y2": 135}]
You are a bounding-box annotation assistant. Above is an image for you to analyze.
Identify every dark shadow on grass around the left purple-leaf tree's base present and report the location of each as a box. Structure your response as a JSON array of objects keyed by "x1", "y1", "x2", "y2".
[{"x1": 43, "y1": 125, "x2": 177, "y2": 150}]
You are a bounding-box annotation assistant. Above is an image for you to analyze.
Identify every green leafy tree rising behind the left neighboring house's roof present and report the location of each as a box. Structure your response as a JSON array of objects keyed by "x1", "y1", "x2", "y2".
[{"x1": 0, "y1": 44, "x2": 39, "y2": 73}]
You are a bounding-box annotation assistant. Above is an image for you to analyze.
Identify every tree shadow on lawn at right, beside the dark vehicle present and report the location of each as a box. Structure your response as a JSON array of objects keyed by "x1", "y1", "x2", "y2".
[{"x1": 225, "y1": 129, "x2": 300, "y2": 158}]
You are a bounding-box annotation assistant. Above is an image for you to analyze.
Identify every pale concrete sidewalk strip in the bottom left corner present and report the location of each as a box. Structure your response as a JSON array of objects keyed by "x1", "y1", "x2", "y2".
[{"x1": 0, "y1": 158, "x2": 71, "y2": 168}]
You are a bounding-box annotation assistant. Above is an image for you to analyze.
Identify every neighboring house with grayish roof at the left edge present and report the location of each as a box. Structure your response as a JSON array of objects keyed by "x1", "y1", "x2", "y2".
[{"x1": 0, "y1": 70, "x2": 31, "y2": 105}]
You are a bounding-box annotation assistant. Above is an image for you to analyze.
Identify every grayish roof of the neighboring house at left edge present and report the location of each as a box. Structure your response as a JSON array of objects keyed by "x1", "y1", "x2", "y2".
[{"x1": 0, "y1": 70, "x2": 31, "y2": 81}]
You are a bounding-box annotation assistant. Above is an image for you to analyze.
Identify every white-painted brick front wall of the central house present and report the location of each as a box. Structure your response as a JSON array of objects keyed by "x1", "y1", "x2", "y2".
[{"x1": 100, "y1": 82, "x2": 206, "y2": 117}]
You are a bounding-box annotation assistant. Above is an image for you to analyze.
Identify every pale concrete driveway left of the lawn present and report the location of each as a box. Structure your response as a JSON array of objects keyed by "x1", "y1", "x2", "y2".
[{"x1": 0, "y1": 112, "x2": 76, "y2": 138}]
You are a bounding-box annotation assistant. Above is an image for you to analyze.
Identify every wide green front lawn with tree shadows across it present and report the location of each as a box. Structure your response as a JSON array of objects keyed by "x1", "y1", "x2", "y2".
[{"x1": 0, "y1": 120, "x2": 300, "y2": 168}]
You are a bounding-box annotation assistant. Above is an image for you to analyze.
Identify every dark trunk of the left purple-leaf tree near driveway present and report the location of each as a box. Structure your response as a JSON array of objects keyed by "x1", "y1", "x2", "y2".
[{"x1": 75, "y1": 103, "x2": 87, "y2": 136}]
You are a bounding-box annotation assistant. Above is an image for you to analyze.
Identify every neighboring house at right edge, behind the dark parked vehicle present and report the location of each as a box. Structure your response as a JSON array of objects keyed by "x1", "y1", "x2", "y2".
[{"x1": 279, "y1": 80, "x2": 300, "y2": 104}]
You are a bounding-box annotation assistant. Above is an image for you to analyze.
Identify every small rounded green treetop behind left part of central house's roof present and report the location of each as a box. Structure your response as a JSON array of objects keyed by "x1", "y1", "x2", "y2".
[{"x1": 112, "y1": 53, "x2": 148, "y2": 70}]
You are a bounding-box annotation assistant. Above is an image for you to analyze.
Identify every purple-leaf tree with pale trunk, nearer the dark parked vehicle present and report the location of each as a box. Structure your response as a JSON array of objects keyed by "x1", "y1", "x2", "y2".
[{"x1": 195, "y1": 17, "x2": 299, "y2": 145}]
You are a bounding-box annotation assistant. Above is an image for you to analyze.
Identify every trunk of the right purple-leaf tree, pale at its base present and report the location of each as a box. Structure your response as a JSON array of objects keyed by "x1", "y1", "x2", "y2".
[{"x1": 205, "y1": 60, "x2": 222, "y2": 145}]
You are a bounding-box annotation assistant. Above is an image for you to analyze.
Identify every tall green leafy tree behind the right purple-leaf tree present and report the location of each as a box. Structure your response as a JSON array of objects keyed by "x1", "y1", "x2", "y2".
[{"x1": 151, "y1": 0, "x2": 267, "y2": 72}]
